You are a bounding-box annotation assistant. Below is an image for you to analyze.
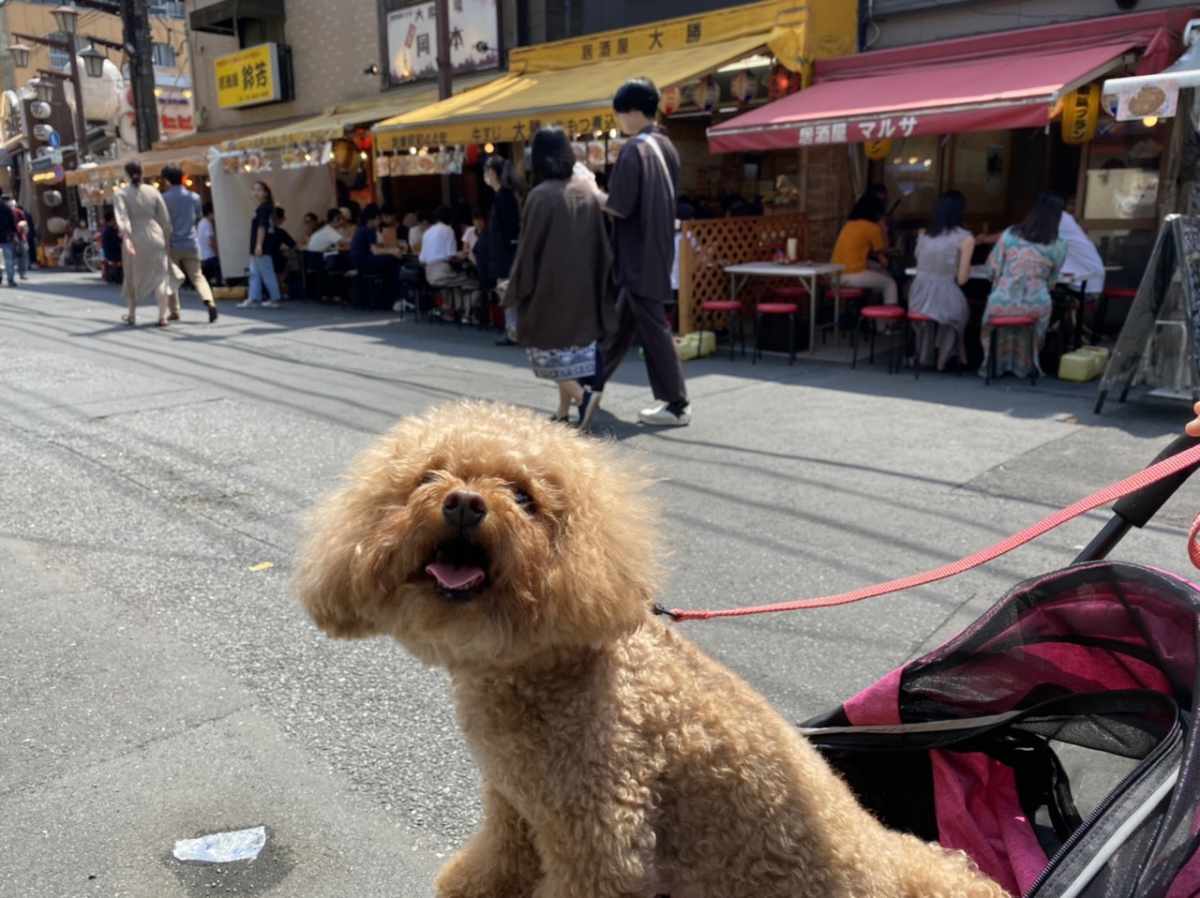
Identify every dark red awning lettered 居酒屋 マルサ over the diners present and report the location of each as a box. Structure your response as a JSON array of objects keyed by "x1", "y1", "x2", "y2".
[{"x1": 708, "y1": 13, "x2": 1185, "y2": 152}]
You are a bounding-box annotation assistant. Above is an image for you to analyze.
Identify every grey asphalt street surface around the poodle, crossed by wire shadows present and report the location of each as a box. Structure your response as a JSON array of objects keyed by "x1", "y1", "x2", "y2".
[{"x1": 0, "y1": 274, "x2": 1200, "y2": 898}]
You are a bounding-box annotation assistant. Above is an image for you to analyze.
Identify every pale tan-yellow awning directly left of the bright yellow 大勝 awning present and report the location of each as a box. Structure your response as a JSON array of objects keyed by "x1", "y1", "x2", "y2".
[{"x1": 220, "y1": 72, "x2": 497, "y2": 151}]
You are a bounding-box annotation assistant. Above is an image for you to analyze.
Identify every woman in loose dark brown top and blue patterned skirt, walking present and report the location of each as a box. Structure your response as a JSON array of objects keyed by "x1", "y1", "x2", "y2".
[{"x1": 504, "y1": 127, "x2": 612, "y2": 421}]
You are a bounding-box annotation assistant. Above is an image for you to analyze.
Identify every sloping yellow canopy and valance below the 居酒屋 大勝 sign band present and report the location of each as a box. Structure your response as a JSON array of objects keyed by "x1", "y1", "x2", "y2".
[{"x1": 374, "y1": 32, "x2": 767, "y2": 150}]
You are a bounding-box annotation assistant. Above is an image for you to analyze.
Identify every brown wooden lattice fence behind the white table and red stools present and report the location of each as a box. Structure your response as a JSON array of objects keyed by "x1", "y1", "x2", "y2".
[{"x1": 679, "y1": 214, "x2": 809, "y2": 334}]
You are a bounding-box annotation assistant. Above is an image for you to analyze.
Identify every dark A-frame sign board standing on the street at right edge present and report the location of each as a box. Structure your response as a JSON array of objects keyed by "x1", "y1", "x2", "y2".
[{"x1": 1096, "y1": 215, "x2": 1200, "y2": 414}]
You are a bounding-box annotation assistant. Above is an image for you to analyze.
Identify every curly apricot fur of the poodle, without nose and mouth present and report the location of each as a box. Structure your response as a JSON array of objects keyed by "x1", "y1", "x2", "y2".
[{"x1": 295, "y1": 403, "x2": 1004, "y2": 898}]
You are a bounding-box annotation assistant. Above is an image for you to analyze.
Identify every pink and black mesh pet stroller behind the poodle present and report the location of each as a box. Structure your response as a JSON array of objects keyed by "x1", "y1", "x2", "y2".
[{"x1": 805, "y1": 438, "x2": 1200, "y2": 898}]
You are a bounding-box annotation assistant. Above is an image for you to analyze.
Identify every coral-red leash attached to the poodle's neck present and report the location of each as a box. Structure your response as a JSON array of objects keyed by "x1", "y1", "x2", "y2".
[{"x1": 654, "y1": 445, "x2": 1200, "y2": 621}]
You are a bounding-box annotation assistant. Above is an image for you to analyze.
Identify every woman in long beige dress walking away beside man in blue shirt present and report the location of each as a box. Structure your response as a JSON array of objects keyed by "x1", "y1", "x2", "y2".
[{"x1": 114, "y1": 160, "x2": 170, "y2": 328}]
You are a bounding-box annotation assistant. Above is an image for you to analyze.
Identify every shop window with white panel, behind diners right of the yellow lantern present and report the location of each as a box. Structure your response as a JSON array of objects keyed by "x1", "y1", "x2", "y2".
[{"x1": 1084, "y1": 122, "x2": 1169, "y2": 222}]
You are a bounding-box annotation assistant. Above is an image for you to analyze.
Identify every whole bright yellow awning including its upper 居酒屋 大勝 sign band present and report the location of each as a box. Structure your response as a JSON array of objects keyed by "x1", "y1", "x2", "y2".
[{"x1": 374, "y1": 0, "x2": 857, "y2": 150}]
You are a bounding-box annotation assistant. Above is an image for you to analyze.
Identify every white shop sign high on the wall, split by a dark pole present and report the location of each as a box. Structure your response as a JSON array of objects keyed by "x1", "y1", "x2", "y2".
[{"x1": 388, "y1": 0, "x2": 500, "y2": 83}]
